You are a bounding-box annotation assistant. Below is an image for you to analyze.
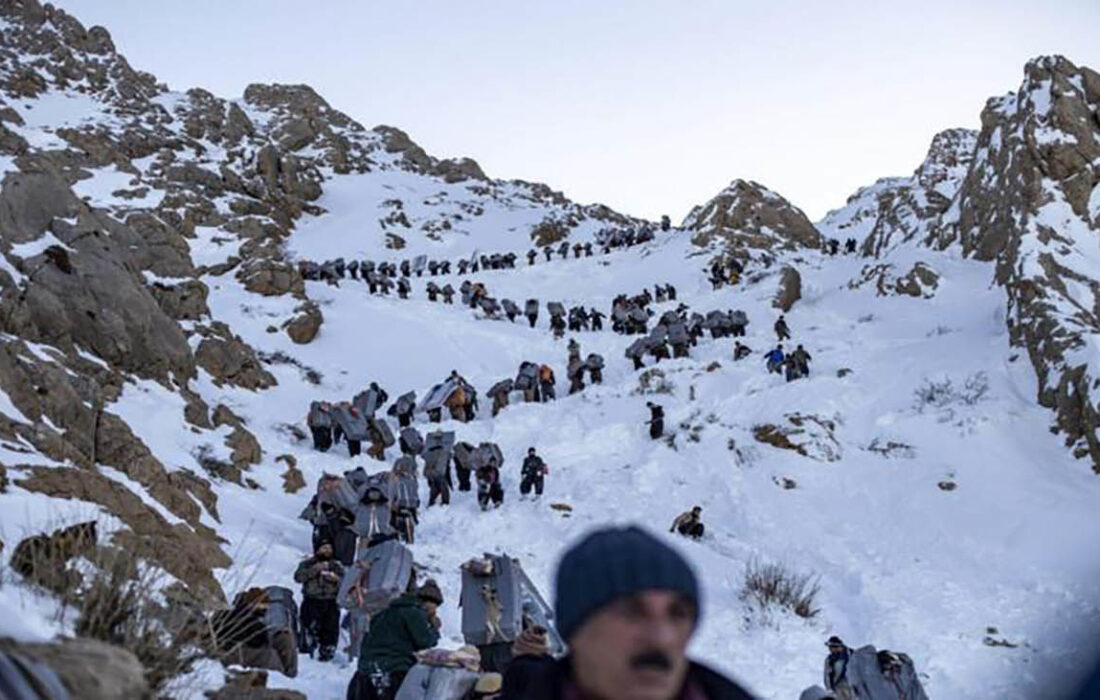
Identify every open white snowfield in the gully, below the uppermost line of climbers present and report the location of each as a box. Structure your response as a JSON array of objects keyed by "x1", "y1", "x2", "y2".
[{"x1": 155, "y1": 228, "x2": 1100, "y2": 700}]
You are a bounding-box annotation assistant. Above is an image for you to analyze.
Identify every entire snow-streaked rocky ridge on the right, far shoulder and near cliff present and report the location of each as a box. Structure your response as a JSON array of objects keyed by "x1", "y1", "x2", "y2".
[{"x1": 818, "y1": 56, "x2": 1100, "y2": 472}]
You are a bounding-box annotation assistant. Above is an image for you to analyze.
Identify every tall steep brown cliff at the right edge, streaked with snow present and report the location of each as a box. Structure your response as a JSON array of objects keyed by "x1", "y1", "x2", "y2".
[{"x1": 935, "y1": 56, "x2": 1100, "y2": 471}]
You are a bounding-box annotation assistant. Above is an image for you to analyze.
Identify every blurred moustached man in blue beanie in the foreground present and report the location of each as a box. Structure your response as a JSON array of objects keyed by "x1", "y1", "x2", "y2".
[{"x1": 519, "y1": 527, "x2": 751, "y2": 700}]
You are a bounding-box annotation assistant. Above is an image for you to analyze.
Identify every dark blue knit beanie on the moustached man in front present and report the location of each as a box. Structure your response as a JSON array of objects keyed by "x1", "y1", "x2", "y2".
[{"x1": 554, "y1": 526, "x2": 702, "y2": 641}]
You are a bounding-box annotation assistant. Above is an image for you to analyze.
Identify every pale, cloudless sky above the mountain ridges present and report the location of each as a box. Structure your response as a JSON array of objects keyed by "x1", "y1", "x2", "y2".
[{"x1": 57, "y1": 0, "x2": 1100, "y2": 221}]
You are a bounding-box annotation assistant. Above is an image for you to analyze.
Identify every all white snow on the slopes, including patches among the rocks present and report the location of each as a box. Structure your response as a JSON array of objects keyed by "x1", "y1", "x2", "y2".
[{"x1": 0, "y1": 56, "x2": 1100, "y2": 700}]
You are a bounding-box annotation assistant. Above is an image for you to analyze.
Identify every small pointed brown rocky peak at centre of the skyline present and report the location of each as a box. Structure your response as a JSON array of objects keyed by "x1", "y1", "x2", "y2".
[{"x1": 682, "y1": 179, "x2": 823, "y2": 250}]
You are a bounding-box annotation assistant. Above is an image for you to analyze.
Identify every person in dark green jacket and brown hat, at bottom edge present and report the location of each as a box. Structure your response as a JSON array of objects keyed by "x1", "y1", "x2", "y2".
[{"x1": 348, "y1": 579, "x2": 443, "y2": 700}]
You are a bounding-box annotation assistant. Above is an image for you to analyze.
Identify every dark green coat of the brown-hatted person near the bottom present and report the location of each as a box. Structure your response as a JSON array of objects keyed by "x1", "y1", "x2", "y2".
[{"x1": 359, "y1": 594, "x2": 439, "y2": 675}]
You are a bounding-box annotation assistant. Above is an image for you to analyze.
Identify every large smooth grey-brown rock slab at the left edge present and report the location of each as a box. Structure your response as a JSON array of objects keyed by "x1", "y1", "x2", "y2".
[{"x1": 0, "y1": 164, "x2": 195, "y2": 381}]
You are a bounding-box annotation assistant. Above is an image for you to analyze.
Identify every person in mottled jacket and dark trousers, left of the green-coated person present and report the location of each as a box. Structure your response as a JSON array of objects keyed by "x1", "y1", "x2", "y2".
[{"x1": 294, "y1": 542, "x2": 344, "y2": 661}]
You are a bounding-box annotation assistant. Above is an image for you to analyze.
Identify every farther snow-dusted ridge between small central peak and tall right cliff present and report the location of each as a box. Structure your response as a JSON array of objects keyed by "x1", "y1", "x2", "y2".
[{"x1": 817, "y1": 129, "x2": 978, "y2": 258}]
